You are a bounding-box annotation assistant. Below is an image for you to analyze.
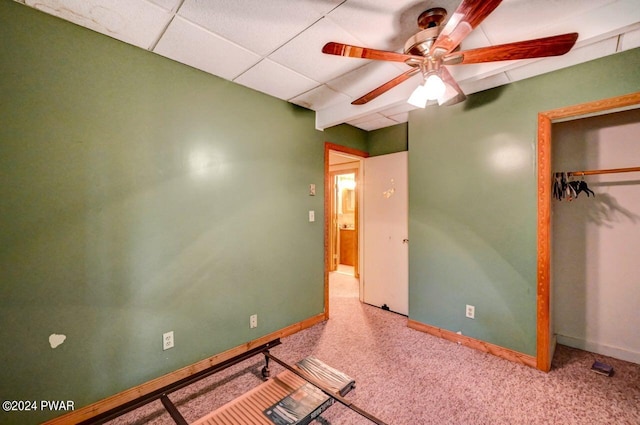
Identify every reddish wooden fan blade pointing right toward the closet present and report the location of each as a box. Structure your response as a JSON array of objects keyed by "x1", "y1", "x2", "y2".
[{"x1": 443, "y1": 32, "x2": 578, "y2": 65}]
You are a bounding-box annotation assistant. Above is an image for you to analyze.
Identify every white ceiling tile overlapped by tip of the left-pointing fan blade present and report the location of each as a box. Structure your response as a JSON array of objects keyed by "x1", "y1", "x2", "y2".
[{"x1": 269, "y1": 18, "x2": 369, "y2": 81}]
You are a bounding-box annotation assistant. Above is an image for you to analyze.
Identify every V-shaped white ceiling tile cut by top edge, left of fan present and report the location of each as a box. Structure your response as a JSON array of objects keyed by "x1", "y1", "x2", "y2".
[{"x1": 179, "y1": 0, "x2": 340, "y2": 56}]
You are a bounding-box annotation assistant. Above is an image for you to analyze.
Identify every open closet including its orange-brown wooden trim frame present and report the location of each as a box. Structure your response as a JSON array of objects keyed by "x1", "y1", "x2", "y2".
[{"x1": 537, "y1": 93, "x2": 640, "y2": 371}]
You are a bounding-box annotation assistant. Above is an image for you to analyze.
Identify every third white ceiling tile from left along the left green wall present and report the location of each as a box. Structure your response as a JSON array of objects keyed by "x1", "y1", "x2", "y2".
[{"x1": 234, "y1": 59, "x2": 320, "y2": 100}]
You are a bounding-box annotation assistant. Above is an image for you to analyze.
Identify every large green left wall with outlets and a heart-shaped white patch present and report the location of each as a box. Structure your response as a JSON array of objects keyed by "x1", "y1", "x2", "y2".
[{"x1": 0, "y1": 0, "x2": 366, "y2": 424}]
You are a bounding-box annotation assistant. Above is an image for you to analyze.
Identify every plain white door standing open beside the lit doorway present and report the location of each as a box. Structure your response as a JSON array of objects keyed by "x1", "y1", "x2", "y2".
[{"x1": 362, "y1": 152, "x2": 409, "y2": 315}]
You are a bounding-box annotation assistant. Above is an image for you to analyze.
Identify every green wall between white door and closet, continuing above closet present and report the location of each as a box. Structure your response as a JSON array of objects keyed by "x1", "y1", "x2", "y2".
[{"x1": 409, "y1": 49, "x2": 640, "y2": 355}]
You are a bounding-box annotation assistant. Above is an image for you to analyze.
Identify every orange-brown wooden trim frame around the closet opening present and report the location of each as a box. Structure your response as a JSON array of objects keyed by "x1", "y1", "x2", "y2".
[{"x1": 536, "y1": 92, "x2": 640, "y2": 372}]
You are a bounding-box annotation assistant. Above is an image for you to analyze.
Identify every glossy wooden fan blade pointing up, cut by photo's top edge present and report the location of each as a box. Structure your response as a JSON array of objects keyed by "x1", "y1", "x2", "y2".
[{"x1": 429, "y1": 0, "x2": 502, "y2": 58}]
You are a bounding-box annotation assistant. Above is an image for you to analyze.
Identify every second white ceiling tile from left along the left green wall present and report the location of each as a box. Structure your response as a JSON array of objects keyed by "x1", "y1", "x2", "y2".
[{"x1": 154, "y1": 17, "x2": 261, "y2": 80}]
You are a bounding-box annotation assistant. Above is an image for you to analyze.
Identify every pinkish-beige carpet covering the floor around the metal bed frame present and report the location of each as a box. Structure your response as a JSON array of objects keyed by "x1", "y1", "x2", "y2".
[{"x1": 112, "y1": 273, "x2": 640, "y2": 425}]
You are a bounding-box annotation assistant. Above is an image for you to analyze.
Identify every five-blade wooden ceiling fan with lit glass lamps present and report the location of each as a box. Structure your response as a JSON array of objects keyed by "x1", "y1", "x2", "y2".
[{"x1": 322, "y1": 0, "x2": 578, "y2": 108}]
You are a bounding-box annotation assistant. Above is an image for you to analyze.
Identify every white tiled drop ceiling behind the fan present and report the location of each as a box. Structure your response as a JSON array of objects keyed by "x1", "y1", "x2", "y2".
[{"x1": 16, "y1": 0, "x2": 640, "y2": 131}]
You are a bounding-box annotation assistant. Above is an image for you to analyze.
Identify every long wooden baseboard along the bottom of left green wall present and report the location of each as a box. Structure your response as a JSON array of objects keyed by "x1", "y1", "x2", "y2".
[{"x1": 43, "y1": 313, "x2": 326, "y2": 425}]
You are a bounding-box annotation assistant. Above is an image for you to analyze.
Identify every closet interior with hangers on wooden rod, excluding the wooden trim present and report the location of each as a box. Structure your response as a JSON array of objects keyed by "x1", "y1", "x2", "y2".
[{"x1": 551, "y1": 109, "x2": 640, "y2": 364}]
